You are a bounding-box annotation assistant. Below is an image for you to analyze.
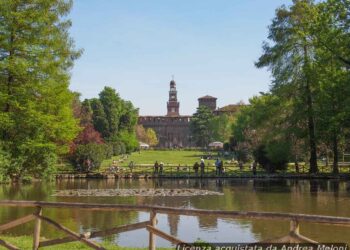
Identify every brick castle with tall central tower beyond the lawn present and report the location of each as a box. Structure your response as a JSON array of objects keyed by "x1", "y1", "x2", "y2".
[{"x1": 138, "y1": 80, "x2": 242, "y2": 148}]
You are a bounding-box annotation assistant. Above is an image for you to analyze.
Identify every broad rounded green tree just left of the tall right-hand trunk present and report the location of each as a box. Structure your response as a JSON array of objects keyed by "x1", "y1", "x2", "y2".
[{"x1": 233, "y1": 93, "x2": 294, "y2": 172}]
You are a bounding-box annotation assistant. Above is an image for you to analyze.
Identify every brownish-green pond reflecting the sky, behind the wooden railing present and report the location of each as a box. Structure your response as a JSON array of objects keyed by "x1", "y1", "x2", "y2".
[{"x1": 0, "y1": 179, "x2": 350, "y2": 247}]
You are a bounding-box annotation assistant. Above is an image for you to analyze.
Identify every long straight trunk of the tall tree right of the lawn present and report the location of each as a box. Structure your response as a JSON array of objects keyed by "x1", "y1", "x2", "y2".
[{"x1": 304, "y1": 46, "x2": 318, "y2": 173}]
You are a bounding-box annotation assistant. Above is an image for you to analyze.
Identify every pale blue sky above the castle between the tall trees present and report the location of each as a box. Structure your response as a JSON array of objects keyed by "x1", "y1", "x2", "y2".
[{"x1": 69, "y1": 0, "x2": 291, "y2": 115}]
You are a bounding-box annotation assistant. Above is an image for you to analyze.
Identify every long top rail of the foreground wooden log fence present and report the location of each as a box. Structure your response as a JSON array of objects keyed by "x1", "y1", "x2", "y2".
[{"x1": 0, "y1": 200, "x2": 350, "y2": 226}]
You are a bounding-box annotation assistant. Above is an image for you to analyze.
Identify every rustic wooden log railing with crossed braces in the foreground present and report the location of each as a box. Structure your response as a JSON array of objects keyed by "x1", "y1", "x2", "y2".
[{"x1": 0, "y1": 201, "x2": 350, "y2": 250}]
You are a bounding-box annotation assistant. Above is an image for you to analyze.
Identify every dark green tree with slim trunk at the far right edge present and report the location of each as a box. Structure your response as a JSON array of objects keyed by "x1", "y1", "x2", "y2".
[{"x1": 316, "y1": 45, "x2": 350, "y2": 174}]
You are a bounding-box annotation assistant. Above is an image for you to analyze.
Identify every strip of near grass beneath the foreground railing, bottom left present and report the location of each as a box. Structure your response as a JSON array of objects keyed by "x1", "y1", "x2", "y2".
[{"x1": 0, "y1": 235, "x2": 171, "y2": 250}]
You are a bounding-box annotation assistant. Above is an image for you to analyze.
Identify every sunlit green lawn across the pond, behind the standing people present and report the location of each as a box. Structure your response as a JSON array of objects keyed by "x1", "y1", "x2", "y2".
[{"x1": 58, "y1": 150, "x2": 350, "y2": 177}]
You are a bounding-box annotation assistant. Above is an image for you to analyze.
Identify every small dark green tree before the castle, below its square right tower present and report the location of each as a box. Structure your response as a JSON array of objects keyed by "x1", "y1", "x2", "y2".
[{"x1": 190, "y1": 106, "x2": 214, "y2": 147}]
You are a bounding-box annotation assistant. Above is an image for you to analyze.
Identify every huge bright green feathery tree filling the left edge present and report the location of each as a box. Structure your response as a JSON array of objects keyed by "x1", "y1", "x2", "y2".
[{"x1": 0, "y1": 0, "x2": 80, "y2": 178}]
